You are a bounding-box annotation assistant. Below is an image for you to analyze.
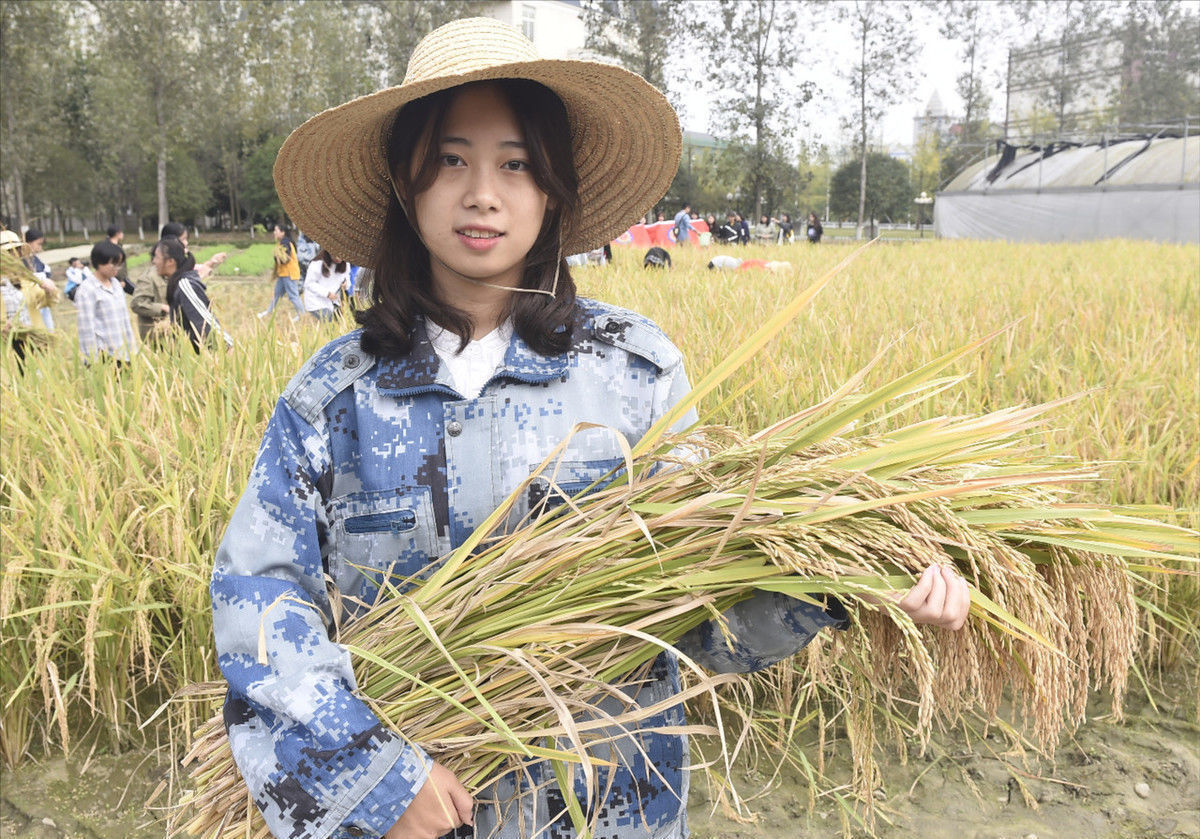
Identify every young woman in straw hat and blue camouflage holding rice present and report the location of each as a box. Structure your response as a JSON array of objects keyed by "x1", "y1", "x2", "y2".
[{"x1": 211, "y1": 19, "x2": 965, "y2": 839}]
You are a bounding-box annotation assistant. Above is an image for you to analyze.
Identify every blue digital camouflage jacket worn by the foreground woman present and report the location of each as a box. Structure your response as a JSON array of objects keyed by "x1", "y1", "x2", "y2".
[{"x1": 211, "y1": 300, "x2": 844, "y2": 839}]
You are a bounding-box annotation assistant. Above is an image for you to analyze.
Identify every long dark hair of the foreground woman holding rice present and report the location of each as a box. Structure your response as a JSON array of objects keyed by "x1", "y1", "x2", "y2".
[{"x1": 355, "y1": 79, "x2": 578, "y2": 358}]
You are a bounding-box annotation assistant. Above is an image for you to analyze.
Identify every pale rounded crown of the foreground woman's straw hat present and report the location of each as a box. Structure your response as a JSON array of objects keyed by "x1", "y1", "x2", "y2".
[{"x1": 404, "y1": 18, "x2": 539, "y2": 84}]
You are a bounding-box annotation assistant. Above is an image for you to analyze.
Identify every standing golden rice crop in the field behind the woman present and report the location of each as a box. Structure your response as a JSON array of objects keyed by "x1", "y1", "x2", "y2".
[{"x1": 0, "y1": 241, "x2": 1200, "y2": 830}]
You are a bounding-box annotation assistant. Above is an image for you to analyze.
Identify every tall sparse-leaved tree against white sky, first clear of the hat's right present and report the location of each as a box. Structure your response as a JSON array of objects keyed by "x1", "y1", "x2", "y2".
[{"x1": 694, "y1": 0, "x2": 814, "y2": 215}]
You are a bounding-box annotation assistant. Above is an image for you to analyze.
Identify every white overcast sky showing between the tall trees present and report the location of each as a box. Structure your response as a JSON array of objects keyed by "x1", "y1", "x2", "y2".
[{"x1": 672, "y1": 0, "x2": 1020, "y2": 148}]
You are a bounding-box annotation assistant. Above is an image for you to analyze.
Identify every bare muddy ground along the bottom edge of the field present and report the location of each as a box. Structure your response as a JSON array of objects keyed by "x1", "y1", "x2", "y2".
[{"x1": 0, "y1": 691, "x2": 1200, "y2": 839}]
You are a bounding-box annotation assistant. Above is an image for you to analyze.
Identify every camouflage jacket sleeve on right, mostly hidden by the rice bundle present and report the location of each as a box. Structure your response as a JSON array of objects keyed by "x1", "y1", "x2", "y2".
[{"x1": 655, "y1": 355, "x2": 850, "y2": 673}]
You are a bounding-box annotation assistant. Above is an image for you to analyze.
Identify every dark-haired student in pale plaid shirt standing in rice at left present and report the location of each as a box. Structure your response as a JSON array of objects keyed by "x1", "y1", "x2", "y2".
[{"x1": 74, "y1": 239, "x2": 138, "y2": 364}]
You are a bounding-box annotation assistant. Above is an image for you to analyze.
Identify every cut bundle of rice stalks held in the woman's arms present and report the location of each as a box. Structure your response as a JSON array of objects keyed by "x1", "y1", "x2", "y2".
[{"x1": 164, "y1": 250, "x2": 1200, "y2": 838}]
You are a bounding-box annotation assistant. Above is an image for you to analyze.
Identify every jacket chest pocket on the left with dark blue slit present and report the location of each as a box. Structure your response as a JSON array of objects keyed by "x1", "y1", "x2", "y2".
[{"x1": 329, "y1": 486, "x2": 438, "y2": 600}]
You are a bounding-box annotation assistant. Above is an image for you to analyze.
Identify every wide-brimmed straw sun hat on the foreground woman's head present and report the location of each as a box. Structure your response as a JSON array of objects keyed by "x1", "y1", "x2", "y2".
[{"x1": 275, "y1": 18, "x2": 682, "y2": 268}]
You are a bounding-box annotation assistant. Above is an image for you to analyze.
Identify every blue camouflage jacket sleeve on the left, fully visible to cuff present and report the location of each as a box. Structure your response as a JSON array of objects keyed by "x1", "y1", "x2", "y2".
[{"x1": 211, "y1": 400, "x2": 432, "y2": 839}]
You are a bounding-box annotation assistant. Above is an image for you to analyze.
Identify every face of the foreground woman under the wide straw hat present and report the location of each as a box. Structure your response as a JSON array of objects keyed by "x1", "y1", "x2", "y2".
[{"x1": 413, "y1": 85, "x2": 547, "y2": 302}]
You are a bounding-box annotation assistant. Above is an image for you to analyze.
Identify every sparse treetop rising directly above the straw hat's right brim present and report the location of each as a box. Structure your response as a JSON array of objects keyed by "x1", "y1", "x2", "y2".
[{"x1": 582, "y1": 0, "x2": 694, "y2": 95}]
